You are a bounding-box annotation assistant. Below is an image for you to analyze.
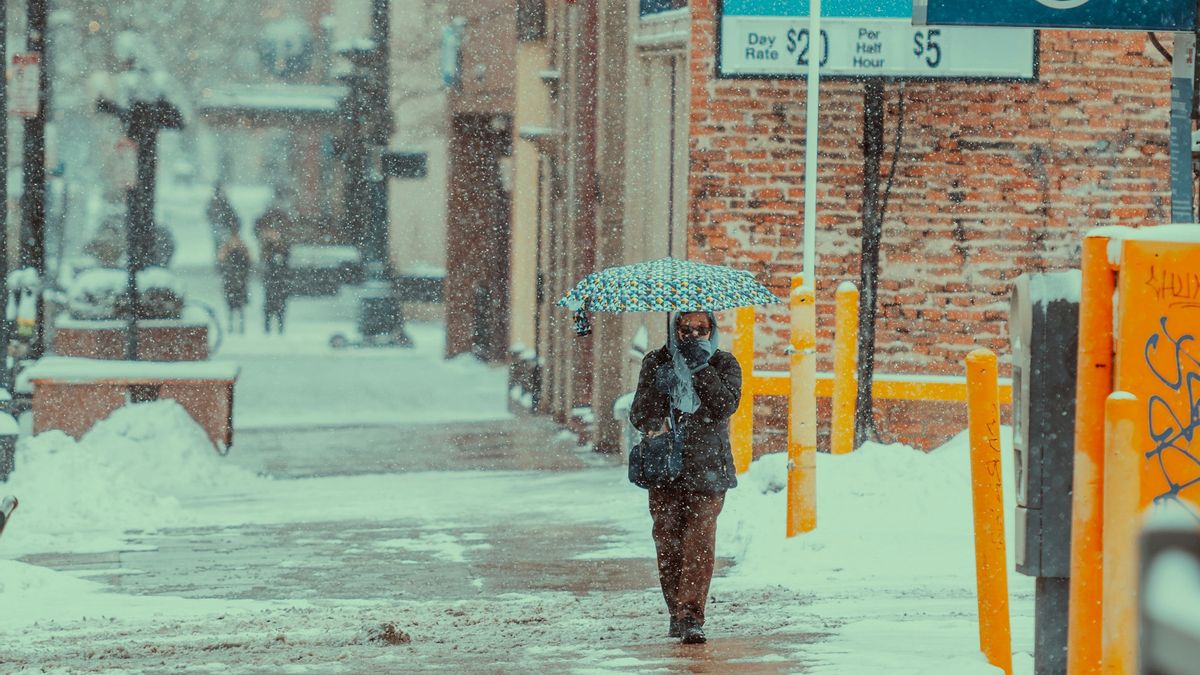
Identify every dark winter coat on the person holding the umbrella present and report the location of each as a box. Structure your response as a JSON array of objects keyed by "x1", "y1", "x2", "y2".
[{"x1": 629, "y1": 347, "x2": 742, "y2": 492}]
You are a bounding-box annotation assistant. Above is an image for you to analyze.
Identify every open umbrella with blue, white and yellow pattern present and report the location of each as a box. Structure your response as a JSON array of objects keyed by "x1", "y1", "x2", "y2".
[{"x1": 558, "y1": 258, "x2": 780, "y2": 335}]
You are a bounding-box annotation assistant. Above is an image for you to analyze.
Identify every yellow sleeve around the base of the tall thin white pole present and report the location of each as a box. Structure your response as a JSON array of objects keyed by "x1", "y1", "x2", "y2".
[{"x1": 787, "y1": 275, "x2": 817, "y2": 537}]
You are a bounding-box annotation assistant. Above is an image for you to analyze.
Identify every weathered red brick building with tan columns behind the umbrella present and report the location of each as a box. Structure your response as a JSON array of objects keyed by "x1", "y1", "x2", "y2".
[{"x1": 510, "y1": 0, "x2": 1170, "y2": 449}]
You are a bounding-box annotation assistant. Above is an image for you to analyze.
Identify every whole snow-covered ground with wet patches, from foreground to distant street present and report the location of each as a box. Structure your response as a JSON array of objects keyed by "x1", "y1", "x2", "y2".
[{"x1": 0, "y1": 266, "x2": 1033, "y2": 675}]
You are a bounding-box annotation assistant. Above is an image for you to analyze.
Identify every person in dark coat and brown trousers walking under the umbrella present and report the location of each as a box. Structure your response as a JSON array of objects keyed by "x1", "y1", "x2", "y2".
[{"x1": 629, "y1": 312, "x2": 742, "y2": 644}]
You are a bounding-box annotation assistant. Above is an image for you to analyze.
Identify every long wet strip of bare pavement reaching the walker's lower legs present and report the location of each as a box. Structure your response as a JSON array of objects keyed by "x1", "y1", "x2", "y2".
[{"x1": 22, "y1": 514, "x2": 655, "y2": 601}]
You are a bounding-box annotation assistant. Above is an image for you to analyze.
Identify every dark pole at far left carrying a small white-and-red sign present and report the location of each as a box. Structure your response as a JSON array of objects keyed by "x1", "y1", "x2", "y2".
[{"x1": 19, "y1": 0, "x2": 49, "y2": 358}]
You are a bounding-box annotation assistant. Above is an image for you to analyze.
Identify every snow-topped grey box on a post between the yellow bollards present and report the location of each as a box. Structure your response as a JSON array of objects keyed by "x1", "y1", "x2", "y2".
[{"x1": 1008, "y1": 270, "x2": 1081, "y2": 675}]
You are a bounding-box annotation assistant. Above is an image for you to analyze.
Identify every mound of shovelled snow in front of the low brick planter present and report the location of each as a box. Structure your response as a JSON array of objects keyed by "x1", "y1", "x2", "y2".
[{"x1": 5, "y1": 400, "x2": 259, "y2": 550}]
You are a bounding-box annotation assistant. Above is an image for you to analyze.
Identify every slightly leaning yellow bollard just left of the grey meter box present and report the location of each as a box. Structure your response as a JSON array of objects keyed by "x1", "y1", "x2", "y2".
[{"x1": 966, "y1": 350, "x2": 1013, "y2": 675}]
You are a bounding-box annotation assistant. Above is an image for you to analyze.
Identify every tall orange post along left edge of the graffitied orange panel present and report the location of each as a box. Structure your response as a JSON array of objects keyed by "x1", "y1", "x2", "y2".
[{"x1": 1067, "y1": 237, "x2": 1115, "y2": 675}]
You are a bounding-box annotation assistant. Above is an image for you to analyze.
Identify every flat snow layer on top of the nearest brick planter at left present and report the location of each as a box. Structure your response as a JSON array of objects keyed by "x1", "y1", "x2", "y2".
[{"x1": 24, "y1": 357, "x2": 241, "y2": 388}]
